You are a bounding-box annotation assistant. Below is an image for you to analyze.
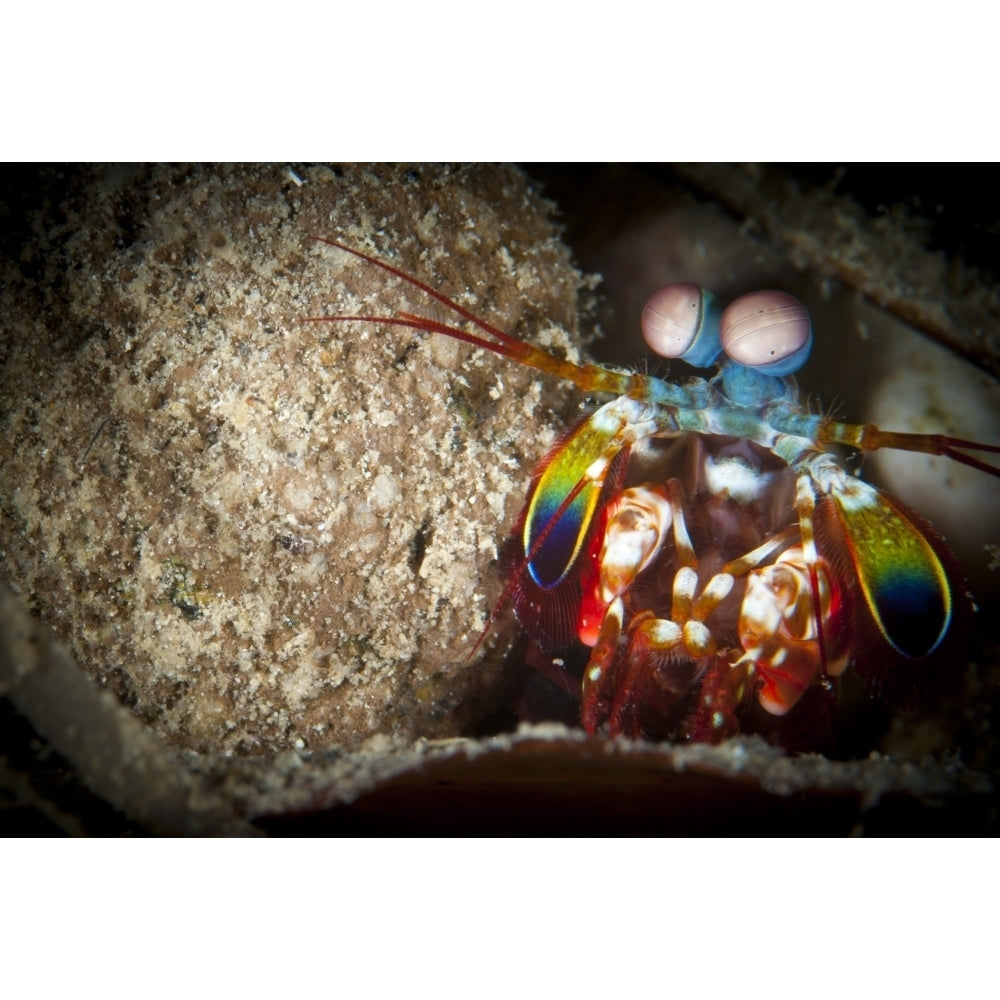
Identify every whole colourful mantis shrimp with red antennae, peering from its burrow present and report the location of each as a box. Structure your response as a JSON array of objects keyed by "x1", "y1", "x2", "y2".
[{"x1": 306, "y1": 237, "x2": 1000, "y2": 740}]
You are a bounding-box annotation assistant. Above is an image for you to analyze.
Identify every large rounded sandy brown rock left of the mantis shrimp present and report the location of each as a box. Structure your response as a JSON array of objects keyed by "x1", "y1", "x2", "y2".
[{"x1": 0, "y1": 167, "x2": 582, "y2": 753}]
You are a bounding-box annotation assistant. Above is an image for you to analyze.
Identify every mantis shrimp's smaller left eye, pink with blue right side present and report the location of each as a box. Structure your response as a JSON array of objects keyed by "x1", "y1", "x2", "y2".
[{"x1": 642, "y1": 281, "x2": 722, "y2": 368}]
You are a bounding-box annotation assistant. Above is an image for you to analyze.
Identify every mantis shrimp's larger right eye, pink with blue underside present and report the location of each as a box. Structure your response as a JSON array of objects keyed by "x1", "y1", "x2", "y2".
[{"x1": 719, "y1": 292, "x2": 812, "y2": 375}]
